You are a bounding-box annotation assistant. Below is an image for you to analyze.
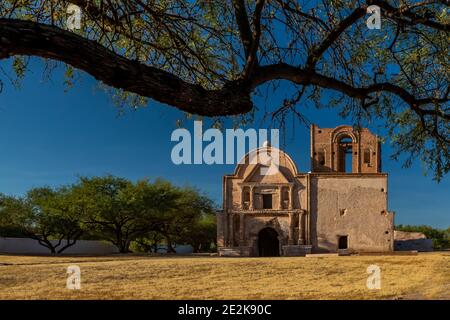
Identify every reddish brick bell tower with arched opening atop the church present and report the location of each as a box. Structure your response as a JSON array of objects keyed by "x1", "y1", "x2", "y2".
[{"x1": 311, "y1": 124, "x2": 381, "y2": 173}]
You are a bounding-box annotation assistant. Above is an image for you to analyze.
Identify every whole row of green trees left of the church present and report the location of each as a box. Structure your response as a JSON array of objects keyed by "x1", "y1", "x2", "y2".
[{"x1": 0, "y1": 175, "x2": 216, "y2": 253}]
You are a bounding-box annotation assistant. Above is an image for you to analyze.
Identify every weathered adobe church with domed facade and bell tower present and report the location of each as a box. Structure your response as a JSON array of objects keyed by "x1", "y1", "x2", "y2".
[{"x1": 217, "y1": 125, "x2": 394, "y2": 256}]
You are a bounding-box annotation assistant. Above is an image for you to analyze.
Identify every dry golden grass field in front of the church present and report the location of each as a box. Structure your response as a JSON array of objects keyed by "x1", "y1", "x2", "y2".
[{"x1": 0, "y1": 252, "x2": 450, "y2": 299}]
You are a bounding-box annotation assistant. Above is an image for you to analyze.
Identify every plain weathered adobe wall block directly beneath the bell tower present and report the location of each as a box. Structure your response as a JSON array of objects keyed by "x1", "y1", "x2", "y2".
[{"x1": 311, "y1": 174, "x2": 393, "y2": 252}]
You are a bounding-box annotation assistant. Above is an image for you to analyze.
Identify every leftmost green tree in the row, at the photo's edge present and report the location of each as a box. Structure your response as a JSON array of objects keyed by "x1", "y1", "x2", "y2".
[{"x1": 0, "y1": 187, "x2": 83, "y2": 254}]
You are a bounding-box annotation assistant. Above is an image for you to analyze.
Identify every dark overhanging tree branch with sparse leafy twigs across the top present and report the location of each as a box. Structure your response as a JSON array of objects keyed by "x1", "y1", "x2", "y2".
[{"x1": 0, "y1": 0, "x2": 450, "y2": 179}]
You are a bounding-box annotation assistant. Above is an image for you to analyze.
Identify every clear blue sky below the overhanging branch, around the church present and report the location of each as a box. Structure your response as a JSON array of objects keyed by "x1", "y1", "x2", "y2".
[{"x1": 0, "y1": 60, "x2": 450, "y2": 228}]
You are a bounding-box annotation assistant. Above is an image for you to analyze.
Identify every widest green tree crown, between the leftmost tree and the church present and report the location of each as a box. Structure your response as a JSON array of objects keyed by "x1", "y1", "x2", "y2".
[{"x1": 73, "y1": 176, "x2": 212, "y2": 253}]
